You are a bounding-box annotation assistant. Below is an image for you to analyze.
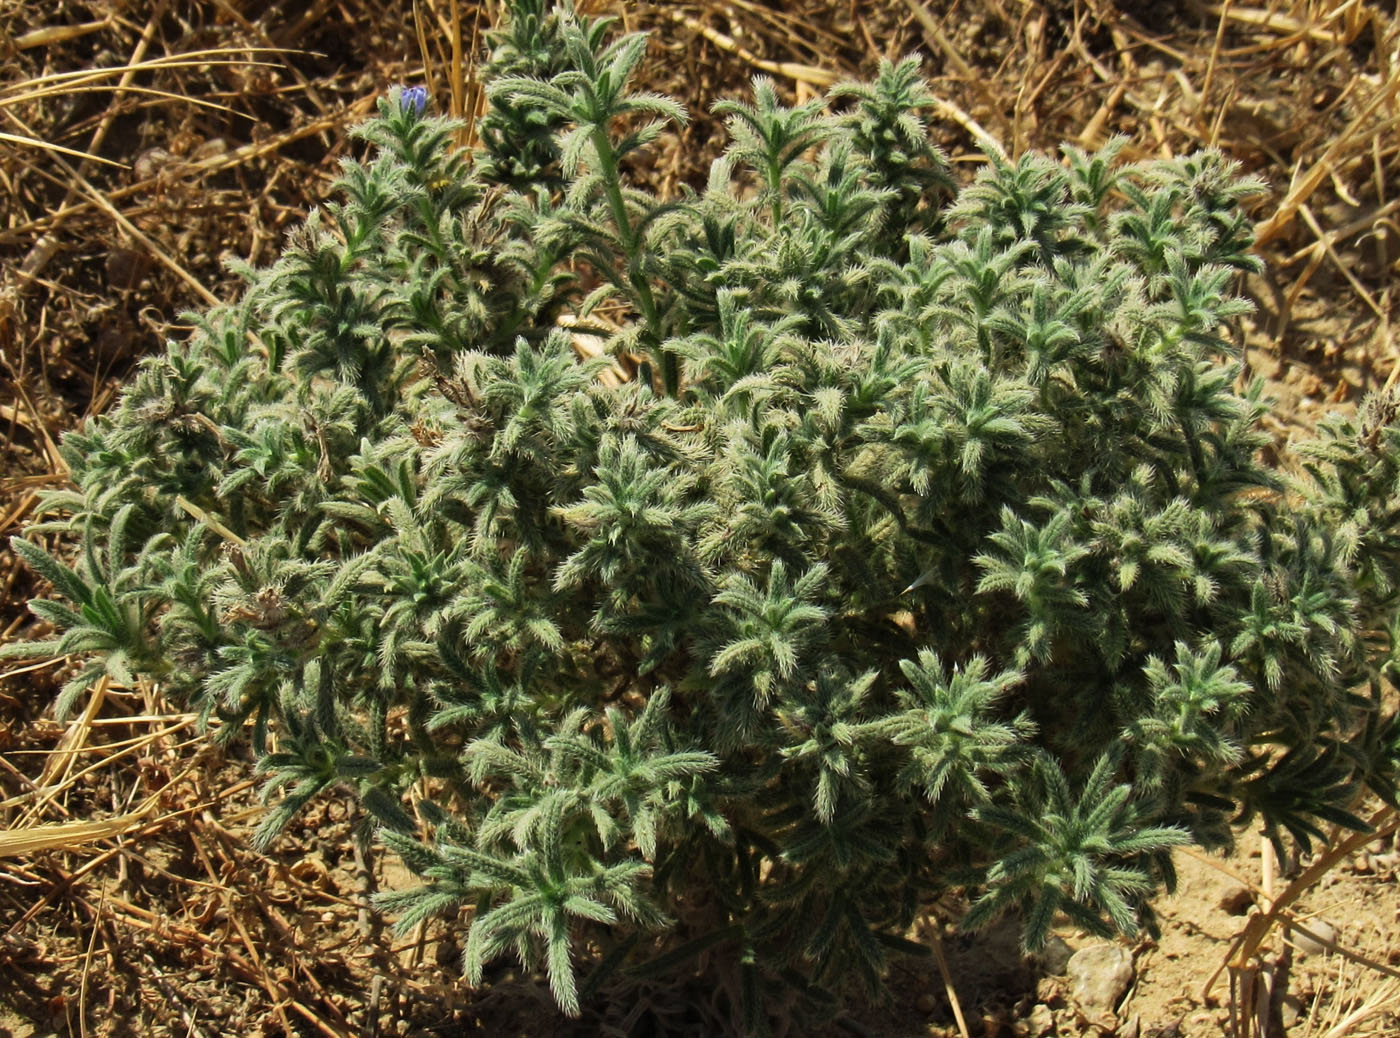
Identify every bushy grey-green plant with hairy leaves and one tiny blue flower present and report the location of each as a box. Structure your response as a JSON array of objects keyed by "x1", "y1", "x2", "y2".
[{"x1": 4, "y1": 0, "x2": 1400, "y2": 1032}]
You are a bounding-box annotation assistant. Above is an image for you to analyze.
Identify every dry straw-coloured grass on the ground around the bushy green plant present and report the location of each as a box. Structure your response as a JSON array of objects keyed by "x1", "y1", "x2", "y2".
[{"x1": 0, "y1": 0, "x2": 1400, "y2": 1037}]
